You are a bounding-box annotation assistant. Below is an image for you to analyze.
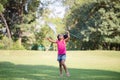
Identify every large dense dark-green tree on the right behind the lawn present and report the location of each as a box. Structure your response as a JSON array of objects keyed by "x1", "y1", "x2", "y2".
[{"x1": 66, "y1": 0, "x2": 120, "y2": 50}]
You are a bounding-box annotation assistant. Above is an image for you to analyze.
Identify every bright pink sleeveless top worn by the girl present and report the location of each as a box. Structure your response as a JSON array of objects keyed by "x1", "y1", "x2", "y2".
[{"x1": 56, "y1": 40, "x2": 66, "y2": 54}]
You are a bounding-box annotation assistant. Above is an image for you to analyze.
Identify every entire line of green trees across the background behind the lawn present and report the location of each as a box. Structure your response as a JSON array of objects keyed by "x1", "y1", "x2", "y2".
[{"x1": 0, "y1": 0, "x2": 120, "y2": 50}]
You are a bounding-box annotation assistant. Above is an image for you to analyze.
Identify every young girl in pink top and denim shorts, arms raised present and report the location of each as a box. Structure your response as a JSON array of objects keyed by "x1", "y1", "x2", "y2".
[{"x1": 48, "y1": 31, "x2": 70, "y2": 76}]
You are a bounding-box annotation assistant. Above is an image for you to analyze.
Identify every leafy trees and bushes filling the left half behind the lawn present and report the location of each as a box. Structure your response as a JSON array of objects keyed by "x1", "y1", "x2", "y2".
[{"x1": 0, "y1": 0, "x2": 59, "y2": 49}]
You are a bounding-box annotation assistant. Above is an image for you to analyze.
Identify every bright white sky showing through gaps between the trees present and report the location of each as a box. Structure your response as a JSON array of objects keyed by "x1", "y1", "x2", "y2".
[{"x1": 36, "y1": 0, "x2": 66, "y2": 34}]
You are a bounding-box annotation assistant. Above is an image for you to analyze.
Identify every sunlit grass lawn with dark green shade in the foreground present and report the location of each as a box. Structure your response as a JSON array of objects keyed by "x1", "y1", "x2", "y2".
[{"x1": 0, "y1": 50, "x2": 120, "y2": 80}]
